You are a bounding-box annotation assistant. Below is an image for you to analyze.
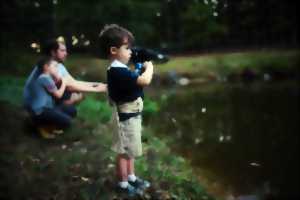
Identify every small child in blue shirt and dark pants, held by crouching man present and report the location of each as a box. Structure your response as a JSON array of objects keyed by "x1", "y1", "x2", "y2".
[{"x1": 24, "y1": 57, "x2": 76, "y2": 139}]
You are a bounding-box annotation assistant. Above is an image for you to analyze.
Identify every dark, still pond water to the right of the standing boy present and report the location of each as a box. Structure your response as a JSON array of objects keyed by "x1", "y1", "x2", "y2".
[{"x1": 150, "y1": 81, "x2": 300, "y2": 199}]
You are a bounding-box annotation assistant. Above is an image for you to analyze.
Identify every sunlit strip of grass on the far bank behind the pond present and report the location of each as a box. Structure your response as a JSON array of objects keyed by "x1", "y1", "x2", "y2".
[{"x1": 158, "y1": 50, "x2": 299, "y2": 76}]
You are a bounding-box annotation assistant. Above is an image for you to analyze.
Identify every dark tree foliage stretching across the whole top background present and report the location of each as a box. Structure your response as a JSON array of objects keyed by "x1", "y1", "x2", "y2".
[{"x1": 0, "y1": 0, "x2": 299, "y2": 57}]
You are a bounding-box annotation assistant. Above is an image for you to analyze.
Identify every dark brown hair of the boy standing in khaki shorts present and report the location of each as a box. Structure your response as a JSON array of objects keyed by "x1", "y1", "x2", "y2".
[{"x1": 99, "y1": 24, "x2": 134, "y2": 58}]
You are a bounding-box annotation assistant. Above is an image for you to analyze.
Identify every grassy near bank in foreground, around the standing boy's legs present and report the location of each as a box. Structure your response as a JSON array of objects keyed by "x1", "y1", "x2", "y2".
[{"x1": 0, "y1": 76, "x2": 214, "y2": 200}]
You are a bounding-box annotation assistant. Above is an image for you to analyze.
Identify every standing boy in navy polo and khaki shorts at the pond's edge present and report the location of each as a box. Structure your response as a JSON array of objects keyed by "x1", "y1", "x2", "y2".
[{"x1": 100, "y1": 24, "x2": 153, "y2": 196}]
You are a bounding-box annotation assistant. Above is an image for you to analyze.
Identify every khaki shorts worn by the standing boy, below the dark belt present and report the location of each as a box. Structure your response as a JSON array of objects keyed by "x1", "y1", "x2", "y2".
[{"x1": 112, "y1": 112, "x2": 142, "y2": 157}]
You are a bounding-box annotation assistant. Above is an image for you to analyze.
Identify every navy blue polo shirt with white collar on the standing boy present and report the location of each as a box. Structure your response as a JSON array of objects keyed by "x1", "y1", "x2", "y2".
[{"x1": 107, "y1": 60, "x2": 144, "y2": 104}]
